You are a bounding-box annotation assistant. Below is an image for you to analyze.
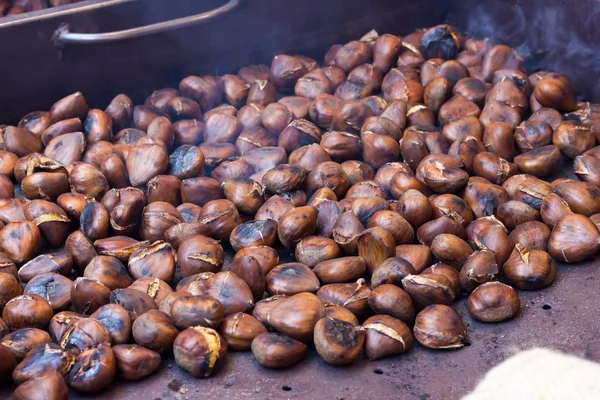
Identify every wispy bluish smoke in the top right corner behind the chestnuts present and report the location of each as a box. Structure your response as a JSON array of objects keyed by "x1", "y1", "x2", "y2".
[{"x1": 453, "y1": 0, "x2": 600, "y2": 102}]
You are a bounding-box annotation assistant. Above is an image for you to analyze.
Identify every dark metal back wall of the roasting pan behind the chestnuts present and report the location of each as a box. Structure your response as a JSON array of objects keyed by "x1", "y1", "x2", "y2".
[{"x1": 0, "y1": 0, "x2": 600, "y2": 123}]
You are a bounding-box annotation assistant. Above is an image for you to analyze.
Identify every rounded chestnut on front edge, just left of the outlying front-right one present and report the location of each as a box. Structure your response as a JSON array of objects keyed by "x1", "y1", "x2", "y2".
[{"x1": 413, "y1": 304, "x2": 467, "y2": 349}]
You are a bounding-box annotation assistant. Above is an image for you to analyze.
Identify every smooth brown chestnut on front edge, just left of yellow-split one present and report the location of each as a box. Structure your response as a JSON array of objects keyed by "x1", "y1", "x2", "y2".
[{"x1": 112, "y1": 344, "x2": 161, "y2": 380}]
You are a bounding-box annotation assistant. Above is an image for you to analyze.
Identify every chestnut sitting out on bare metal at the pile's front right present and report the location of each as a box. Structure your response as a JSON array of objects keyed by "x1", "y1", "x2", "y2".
[{"x1": 467, "y1": 282, "x2": 521, "y2": 322}]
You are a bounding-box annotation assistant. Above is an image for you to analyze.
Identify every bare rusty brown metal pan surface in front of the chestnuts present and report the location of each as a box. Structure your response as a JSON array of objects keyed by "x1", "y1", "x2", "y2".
[{"x1": 0, "y1": 260, "x2": 600, "y2": 400}]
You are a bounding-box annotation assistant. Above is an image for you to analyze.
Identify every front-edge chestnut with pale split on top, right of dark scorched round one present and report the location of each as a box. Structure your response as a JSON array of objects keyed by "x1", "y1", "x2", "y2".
[{"x1": 362, "y1": 315, "x2": 413, "y2": 361}]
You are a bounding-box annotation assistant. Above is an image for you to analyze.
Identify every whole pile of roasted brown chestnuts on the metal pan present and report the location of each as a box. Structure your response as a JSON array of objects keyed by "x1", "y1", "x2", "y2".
[{"x1": 0, "y1": 25, "x2": 600, "y2": 399}]
